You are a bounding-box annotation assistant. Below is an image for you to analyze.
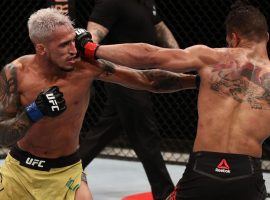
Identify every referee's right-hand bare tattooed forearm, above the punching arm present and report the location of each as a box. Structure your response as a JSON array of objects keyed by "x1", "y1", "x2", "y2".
[{"x1": 155, "y1": 21, "x2": 179, "y2": 49}]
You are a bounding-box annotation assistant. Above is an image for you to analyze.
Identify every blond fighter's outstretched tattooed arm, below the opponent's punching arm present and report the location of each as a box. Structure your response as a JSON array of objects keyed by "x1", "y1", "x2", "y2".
[{"x1": 94, "y1": 60, "x2": 196, "y2": 93}]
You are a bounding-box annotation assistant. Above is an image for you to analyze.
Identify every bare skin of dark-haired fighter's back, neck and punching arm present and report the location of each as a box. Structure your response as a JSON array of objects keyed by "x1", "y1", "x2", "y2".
[{"x1": 96, "y1": 42, "x2": 270, "y2": 157}]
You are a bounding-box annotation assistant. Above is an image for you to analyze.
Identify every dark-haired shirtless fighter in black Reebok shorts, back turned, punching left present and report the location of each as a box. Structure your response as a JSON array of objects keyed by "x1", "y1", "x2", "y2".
[{"x1": 76, "y1": 0, "x2": 270, "y2": 200}]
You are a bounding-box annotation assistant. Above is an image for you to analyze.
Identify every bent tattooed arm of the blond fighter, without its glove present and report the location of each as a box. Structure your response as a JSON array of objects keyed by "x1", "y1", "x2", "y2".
[{"x1": 0, "y1": 64, "x2": 32, "y2": 146}]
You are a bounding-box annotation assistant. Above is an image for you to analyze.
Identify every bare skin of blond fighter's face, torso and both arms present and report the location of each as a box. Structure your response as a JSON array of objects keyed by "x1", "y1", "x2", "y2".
[{"x1": 0, "y1": 27, "x2": 195, "y2": 158}]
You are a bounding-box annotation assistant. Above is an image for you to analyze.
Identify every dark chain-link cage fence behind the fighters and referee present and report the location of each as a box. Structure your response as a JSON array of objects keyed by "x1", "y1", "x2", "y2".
[{"x1": 0, "y1": 0, "x2": 270, "y2": 170}]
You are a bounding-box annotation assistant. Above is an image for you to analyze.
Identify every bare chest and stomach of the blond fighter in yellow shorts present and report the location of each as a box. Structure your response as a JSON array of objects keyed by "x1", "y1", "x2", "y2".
[{"x1": 14, "y1": 56, "x2": 98, "y2": 158}]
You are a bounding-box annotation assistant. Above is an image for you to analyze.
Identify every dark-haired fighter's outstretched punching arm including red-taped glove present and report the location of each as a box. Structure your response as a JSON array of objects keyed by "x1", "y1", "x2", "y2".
[{"x1": 75, "y1": 29, "x2": 226, "y2": 72}]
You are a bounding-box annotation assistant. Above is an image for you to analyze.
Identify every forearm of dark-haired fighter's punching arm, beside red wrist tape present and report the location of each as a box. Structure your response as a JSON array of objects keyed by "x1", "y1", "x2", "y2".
[{"x1": 96, "y1": 43, "x2": 159, "y2": 69}]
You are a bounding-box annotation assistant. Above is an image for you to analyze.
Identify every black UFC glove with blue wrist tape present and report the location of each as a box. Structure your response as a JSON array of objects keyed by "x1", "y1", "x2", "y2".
[{"x1": 25, "y1": 86, "x2": 67, "y2": 122}]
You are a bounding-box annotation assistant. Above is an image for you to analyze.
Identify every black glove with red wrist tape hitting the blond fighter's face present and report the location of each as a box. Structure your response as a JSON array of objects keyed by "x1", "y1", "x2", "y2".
[{"x1": 75, "y1": 28, "x2": 99, "y2": 61}]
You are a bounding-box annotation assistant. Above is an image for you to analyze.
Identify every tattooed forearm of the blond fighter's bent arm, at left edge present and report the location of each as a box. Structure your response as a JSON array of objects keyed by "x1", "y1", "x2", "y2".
[{"x1": 0, "y1": 111, "x2": 32, "y2": 146}]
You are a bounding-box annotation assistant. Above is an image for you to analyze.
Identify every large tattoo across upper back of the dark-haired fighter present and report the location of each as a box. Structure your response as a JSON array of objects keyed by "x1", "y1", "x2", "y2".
[{"x1": 211, "y1": 61, "x2": 270, "y2": 110}]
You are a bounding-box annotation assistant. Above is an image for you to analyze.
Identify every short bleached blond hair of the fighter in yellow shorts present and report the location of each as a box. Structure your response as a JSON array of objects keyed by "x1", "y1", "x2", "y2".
[{"x1": 27, "y1": 8, "x2": 73, "y2": 43}]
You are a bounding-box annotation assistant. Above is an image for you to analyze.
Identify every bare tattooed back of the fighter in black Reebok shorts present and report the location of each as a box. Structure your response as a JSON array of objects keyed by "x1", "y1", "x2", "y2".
[{"x1": 193, "y1": 49, "x2": 270, "y2": 157}]
